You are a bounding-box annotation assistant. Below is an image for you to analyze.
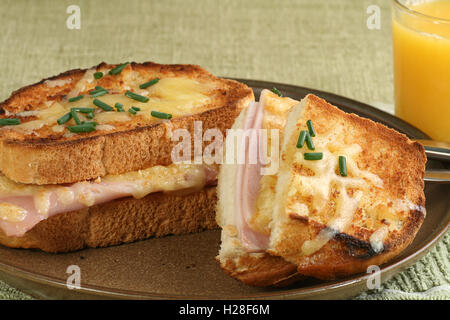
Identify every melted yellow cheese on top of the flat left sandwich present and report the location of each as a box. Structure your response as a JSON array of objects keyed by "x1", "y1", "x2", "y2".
[{"x1": 8, "y1": 74, "x2": 214, "y2": 133}]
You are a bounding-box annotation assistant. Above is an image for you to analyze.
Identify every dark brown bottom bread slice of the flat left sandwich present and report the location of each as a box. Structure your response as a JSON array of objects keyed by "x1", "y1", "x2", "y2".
[{"x1": 0, "y1": 186, "x2": 217, "y2": 253}]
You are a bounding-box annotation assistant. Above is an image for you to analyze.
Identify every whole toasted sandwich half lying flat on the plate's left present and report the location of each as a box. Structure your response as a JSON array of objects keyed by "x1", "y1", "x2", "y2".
[{"x1": 0, "y1": 62, "x2": 254, "y2": 252}]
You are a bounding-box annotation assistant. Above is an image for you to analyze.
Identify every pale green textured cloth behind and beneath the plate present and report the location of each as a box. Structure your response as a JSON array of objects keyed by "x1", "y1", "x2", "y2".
[{"x1": 0, "y1": 0, "x2": 450, "y2": 299}]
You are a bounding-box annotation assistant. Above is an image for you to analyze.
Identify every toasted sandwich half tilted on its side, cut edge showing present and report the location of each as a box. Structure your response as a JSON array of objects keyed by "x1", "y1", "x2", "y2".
[{"x1": 217, "y1": 90, "x2": 426, "y2": 286}]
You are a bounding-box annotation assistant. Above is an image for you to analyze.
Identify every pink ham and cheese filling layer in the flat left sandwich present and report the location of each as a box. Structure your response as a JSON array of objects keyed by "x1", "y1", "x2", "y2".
[{"x1": 0, "y1": 166, "x2": 217, "y2": 237}]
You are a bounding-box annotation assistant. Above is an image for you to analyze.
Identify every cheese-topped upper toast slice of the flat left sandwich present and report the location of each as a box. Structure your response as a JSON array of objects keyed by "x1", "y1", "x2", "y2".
[{"x1": 0, "y1": 62, "x2": 254, "y2": 184}]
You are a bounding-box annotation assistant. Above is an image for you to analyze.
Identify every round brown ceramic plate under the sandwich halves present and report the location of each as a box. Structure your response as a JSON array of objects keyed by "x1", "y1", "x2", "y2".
[{"x1": 0, "y1": 80, "x2": 450, "y2": 299}]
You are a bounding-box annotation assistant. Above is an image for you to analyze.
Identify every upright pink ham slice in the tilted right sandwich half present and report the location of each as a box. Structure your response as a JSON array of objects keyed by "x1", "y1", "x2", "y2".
[{"x1": 234, "y1": 92, "x2": 269, "y2": 252}]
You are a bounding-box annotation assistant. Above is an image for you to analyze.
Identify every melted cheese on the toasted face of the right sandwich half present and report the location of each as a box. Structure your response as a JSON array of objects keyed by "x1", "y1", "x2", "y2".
[{"x1": 275, "y1": 108, "x2": 400, "y2": 255}]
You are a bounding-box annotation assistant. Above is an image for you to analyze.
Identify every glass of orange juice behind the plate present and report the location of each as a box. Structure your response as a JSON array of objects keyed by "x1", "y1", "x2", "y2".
[{"x1": 392, "y1": 0, "x2": 450, "y2": 142}]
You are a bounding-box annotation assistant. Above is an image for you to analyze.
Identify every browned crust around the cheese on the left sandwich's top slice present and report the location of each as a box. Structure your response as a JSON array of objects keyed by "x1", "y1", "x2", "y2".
[{"x1": 0, "y1": 62, "x2": 254, "y2": 185}]
